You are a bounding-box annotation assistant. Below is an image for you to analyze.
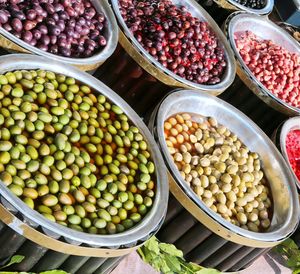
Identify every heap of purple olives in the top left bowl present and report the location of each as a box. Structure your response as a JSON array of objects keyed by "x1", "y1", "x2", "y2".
[{"x1": 0, "y1": 0, "x2": 107, "y2": 58}]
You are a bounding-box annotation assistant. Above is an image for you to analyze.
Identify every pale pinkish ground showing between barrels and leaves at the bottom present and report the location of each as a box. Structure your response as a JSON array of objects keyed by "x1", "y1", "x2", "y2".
[{"x1": 111, "y1": 252, "x2": 292, "y2": 274}]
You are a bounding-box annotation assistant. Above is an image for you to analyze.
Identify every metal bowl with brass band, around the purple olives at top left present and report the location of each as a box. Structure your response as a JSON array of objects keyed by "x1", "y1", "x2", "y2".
[{"x1": 0, "y1": 0, "x2": 118, "y2": 71}]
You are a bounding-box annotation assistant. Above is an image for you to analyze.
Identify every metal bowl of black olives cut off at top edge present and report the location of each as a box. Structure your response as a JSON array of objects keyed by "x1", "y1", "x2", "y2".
[{"x1": 214, "y1": 0, "x2": 274, "y2": 15}]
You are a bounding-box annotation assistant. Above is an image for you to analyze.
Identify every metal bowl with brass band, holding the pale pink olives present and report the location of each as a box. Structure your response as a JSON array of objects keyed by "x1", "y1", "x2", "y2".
[{"x1": 224, "y1": 12, "x2": 300, "y2": 116}]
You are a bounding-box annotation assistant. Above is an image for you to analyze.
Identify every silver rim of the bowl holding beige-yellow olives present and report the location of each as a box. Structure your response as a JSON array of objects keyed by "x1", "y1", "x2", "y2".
[{"x1": 154, "y1": 90, "x2": 299, "y2": 245}]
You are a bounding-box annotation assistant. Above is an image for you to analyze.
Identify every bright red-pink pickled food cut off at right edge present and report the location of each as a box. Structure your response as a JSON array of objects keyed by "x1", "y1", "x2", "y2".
[{"x1": 286, "y1": 129, "x2": 300, "y2": 182}]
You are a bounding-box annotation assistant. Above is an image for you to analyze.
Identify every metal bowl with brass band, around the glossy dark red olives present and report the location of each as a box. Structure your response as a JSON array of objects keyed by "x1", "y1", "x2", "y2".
[{"x1": 111, "y1": 0, "x2": 236, "y2": 95}]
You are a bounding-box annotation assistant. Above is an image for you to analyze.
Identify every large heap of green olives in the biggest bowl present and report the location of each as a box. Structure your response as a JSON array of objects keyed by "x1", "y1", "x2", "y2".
[{"x1": 0, "y1": 70, "x2": 156, "y2": 234}]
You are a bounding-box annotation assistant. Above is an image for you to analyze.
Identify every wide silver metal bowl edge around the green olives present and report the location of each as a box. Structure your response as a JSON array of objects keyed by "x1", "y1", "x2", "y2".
[{"x1": 0, "y1": 54, "x2": 169, "y2": 248}]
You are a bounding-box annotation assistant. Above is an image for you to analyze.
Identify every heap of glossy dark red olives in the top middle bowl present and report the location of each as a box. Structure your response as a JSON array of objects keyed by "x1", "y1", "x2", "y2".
[{"x1": 119, "y1": 0, "x2": 227, "y2": 85}]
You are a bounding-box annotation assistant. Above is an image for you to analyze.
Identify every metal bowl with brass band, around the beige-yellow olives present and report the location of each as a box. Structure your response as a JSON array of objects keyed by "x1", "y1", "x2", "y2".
[{"x1": 150, "y1": 90, "x2": 299, "y2": 248}]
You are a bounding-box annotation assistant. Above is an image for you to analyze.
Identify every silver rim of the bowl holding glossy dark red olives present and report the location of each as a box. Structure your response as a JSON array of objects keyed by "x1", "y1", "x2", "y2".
[{"x1": 110, "y1": 0, "x2": 236, "y2": 91}]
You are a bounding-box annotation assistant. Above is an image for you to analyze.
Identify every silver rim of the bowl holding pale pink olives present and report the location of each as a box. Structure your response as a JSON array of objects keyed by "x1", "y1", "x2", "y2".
[{"x1": 225, "y1": 11, "x2": 300, "y2": 115}]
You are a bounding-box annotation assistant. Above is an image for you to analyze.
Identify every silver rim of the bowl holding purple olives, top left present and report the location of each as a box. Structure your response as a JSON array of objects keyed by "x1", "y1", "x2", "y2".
[{"x1": 0, "y1": 0, "x2": 119, "y2": 66}]
